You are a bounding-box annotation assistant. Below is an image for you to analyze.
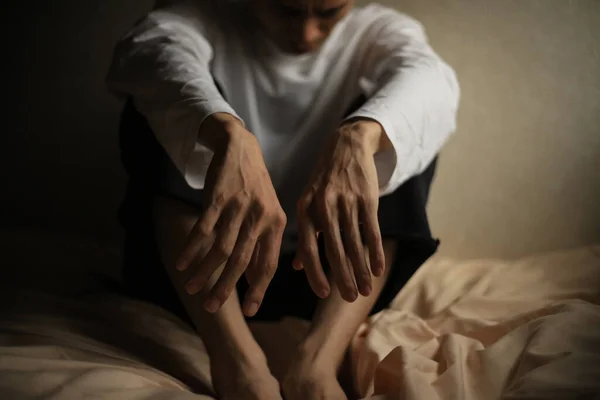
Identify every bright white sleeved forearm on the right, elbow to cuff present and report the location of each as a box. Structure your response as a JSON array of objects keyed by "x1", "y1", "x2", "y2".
[{"x1": 352, "y1": 61, "x2": 458, "y2": 195}]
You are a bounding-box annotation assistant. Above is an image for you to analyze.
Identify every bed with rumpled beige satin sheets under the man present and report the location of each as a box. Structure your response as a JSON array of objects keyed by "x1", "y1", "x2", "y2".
[{"x1": 0, "y1": 229, "x2": 600, "y2": 400}]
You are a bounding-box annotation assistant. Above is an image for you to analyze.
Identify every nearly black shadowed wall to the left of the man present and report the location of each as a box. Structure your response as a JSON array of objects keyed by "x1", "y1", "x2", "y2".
[{"x1": 0, "y1": 0, "x2": 151, "y2": 241}]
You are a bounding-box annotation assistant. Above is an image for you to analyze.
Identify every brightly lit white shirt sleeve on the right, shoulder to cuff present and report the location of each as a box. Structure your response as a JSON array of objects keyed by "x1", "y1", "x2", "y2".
[{"x1": 348, "y1": 7, "x2": 460, "y2": 195}]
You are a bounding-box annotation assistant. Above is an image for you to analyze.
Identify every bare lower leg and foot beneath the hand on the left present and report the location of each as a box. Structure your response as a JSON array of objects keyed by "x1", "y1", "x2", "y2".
[{"x1": 154, "y1": 198, "x2": 281, "y2": 400}]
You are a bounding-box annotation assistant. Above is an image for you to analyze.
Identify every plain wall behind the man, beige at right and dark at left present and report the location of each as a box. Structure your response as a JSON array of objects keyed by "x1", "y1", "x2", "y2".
[{"x1": 0, "y1": 0, "x2": 600, "y2": 257}]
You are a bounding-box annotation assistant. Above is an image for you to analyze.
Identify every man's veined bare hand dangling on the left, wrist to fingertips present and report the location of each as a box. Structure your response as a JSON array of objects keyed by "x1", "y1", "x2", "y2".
[{"x1": 177, "y1": 113, "x2": 286, "y2": 316}]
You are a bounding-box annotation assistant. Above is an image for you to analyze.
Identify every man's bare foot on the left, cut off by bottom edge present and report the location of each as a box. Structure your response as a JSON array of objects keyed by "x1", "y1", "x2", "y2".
[{"x1": 211, "y1": 357, "x2": 282, "y2": 400}]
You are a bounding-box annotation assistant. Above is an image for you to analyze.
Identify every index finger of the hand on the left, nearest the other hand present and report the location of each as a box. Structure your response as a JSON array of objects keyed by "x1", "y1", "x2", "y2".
[{"x1": 243, "y1": 228, "x2": 283, "y2": 317}]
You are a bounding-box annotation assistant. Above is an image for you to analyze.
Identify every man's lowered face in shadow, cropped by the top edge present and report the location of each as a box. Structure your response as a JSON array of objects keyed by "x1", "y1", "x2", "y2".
[{"x1": 253, "y1": 0, "x2": 354, "y2": 54}]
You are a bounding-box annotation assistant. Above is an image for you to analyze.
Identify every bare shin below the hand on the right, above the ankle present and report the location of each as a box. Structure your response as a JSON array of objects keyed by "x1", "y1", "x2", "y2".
[{"x1": 301, "y1": 241, "x2": 396, "y2": 368}]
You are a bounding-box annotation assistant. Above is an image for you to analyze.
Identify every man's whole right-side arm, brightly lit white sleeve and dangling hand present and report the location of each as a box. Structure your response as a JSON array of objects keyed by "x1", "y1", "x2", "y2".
[{"x1": 294, "y1": 6, "x2": 459, "y2": 302}]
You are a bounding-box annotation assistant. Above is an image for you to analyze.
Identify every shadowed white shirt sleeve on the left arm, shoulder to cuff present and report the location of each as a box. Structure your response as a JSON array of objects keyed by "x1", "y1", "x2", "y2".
[{"x1": 107, "y1": 0, "x2": 239, "y2": 189}]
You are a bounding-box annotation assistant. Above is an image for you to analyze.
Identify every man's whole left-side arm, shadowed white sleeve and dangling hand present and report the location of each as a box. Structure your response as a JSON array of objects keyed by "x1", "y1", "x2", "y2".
[{"x1": 108, "y1": 0, "x2": 286, "y2": 316}]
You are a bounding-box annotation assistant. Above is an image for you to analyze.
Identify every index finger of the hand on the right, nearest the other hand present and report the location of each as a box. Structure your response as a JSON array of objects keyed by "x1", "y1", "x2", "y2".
[{"x1": 293, "y1": 202, "x2": 331, "y2": 298}]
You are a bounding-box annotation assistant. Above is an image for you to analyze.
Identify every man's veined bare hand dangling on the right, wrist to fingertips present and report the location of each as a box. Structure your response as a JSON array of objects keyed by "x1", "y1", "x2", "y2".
[{"x1": 294, "y1": 120, "x2": 389, "y2": 302}]
